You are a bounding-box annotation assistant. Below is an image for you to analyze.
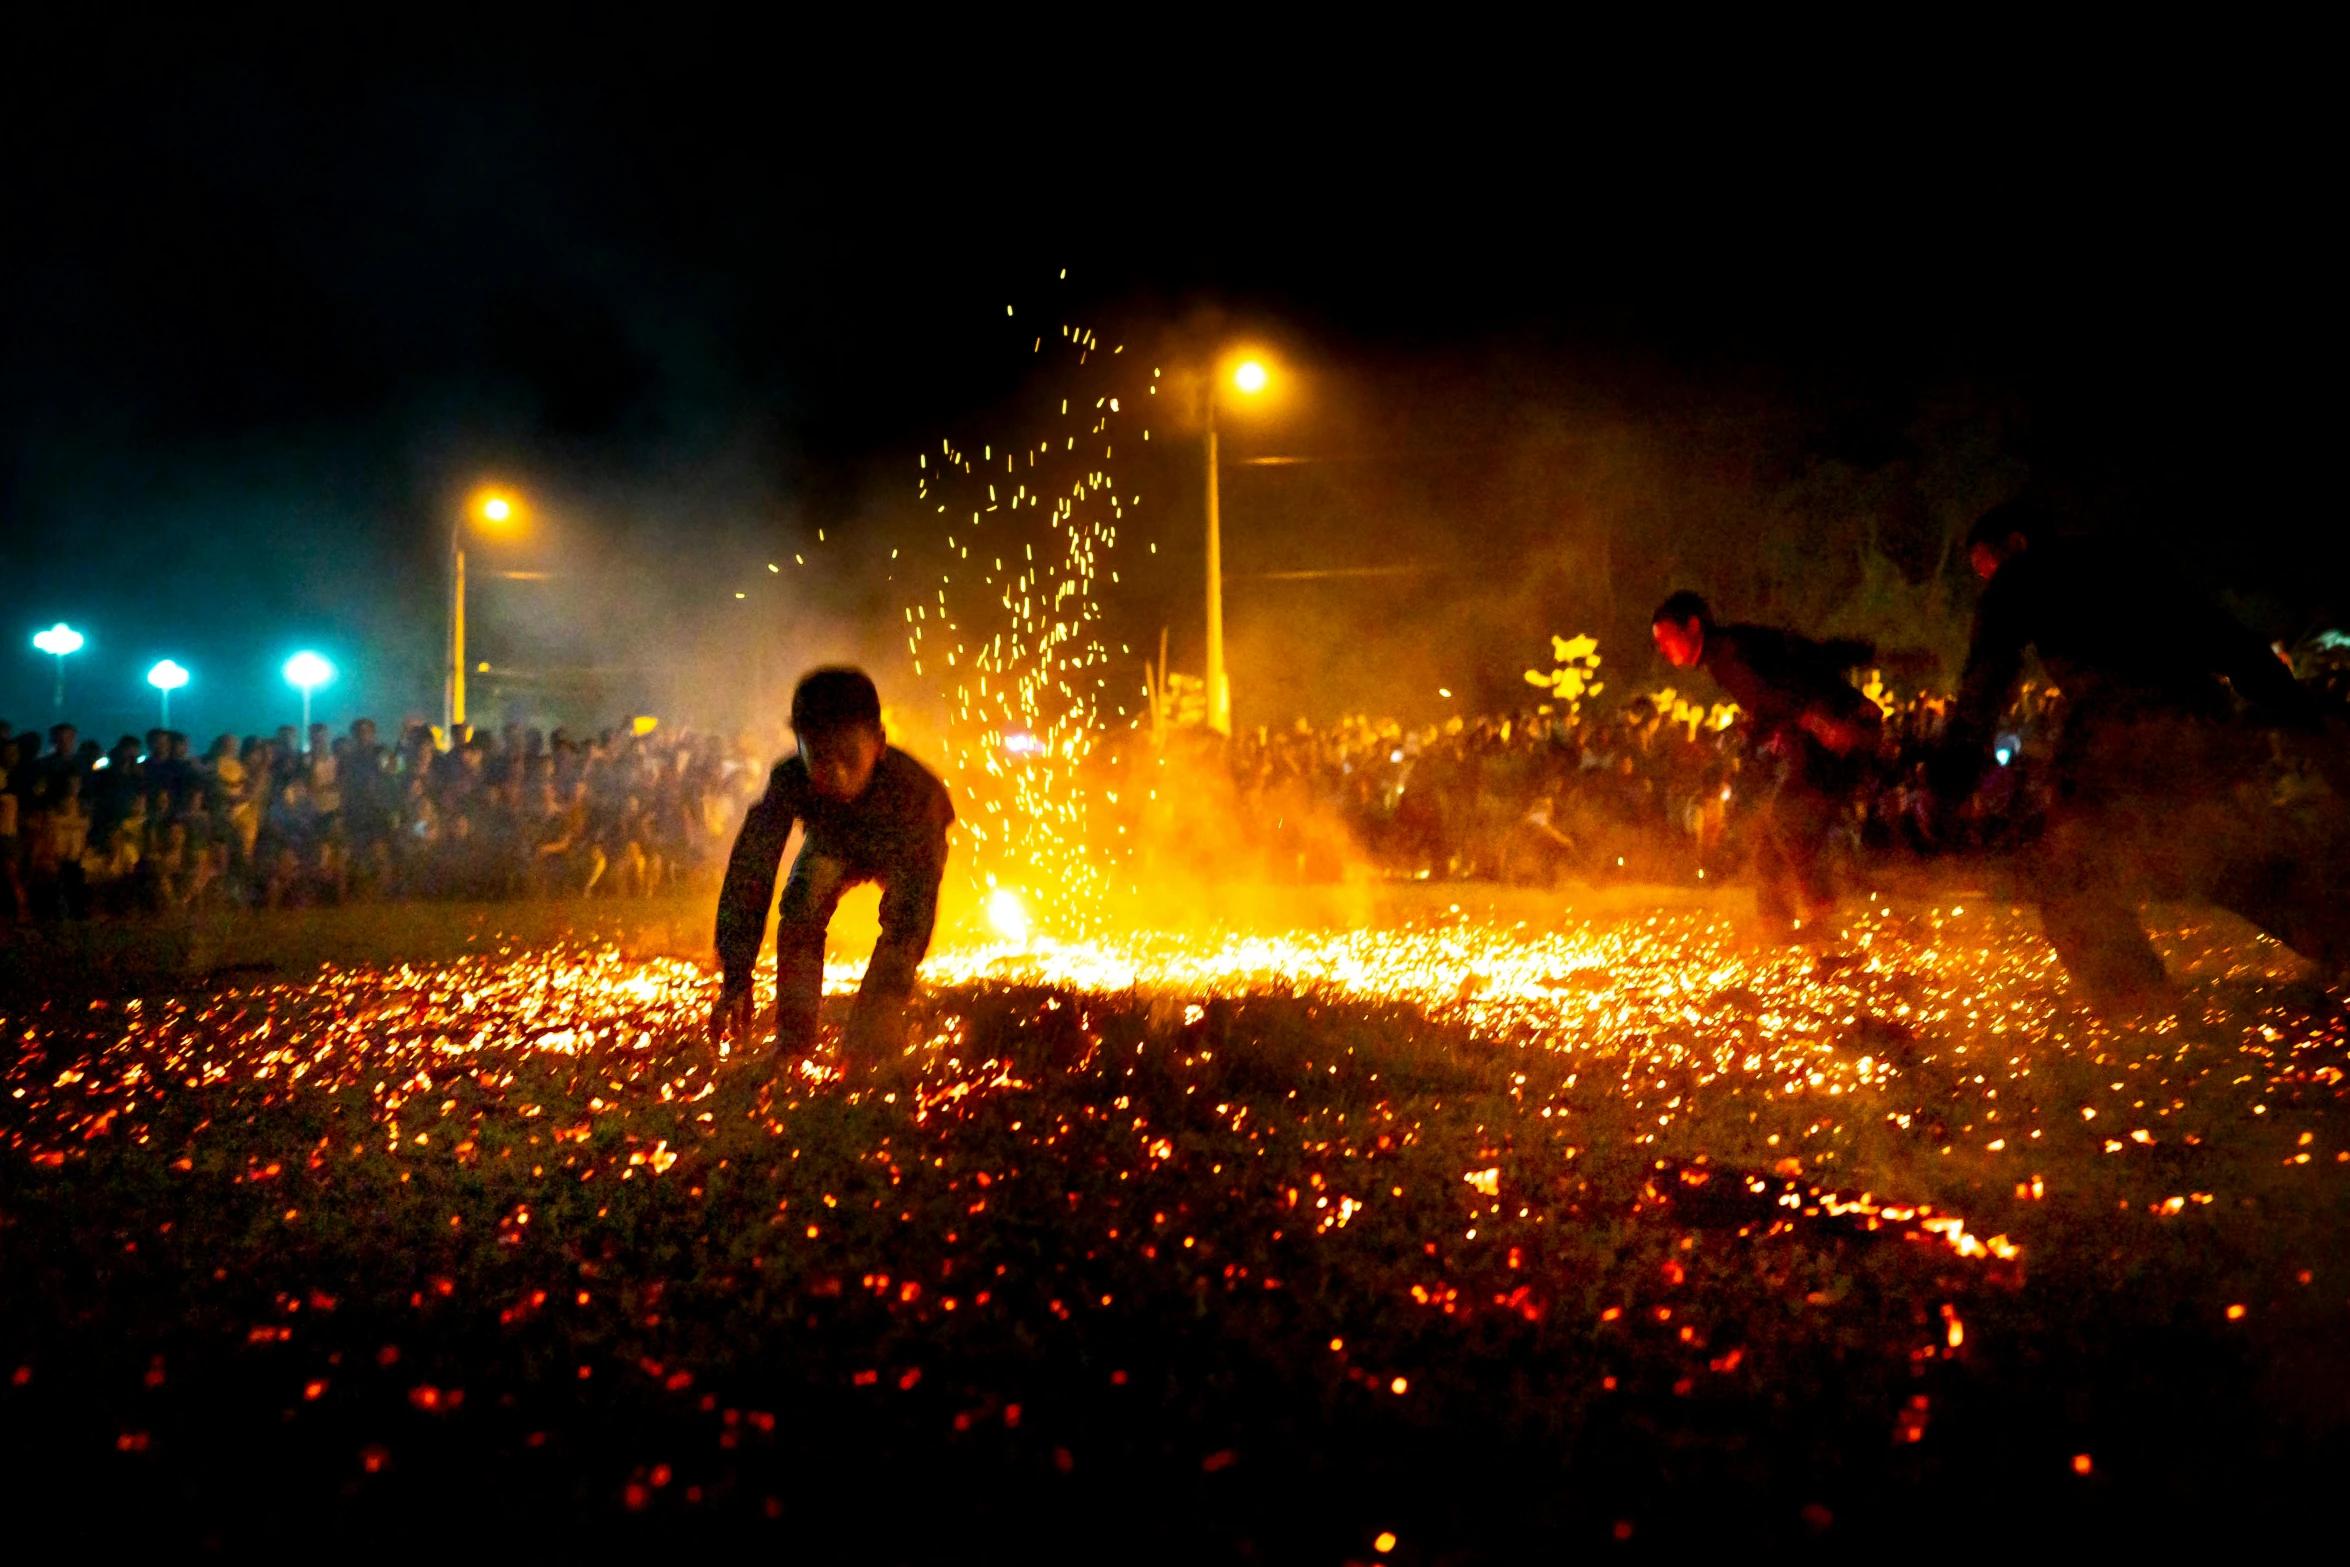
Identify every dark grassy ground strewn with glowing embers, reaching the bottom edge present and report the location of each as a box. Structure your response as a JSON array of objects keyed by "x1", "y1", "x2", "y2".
[{"x1": 0, "y1": 888, "x2": 2350, "y2": 1562}]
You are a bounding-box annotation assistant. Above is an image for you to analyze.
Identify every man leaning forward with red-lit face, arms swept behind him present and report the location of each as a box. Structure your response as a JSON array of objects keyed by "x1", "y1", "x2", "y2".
[{"x1": 1650, "y1": 592, "x2": 1885, "y2": 935}]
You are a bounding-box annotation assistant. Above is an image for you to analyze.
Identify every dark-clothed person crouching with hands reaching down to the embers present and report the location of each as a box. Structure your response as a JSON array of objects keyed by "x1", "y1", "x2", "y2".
[{"x1": 710, "y1": 670, "x2": 954, "y2": 1067}]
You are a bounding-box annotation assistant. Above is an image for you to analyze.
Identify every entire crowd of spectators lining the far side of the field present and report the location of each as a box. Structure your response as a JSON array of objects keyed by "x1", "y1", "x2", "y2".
[{"x1": 0, "y1": 639, "x2": 2350, "y2": 921}]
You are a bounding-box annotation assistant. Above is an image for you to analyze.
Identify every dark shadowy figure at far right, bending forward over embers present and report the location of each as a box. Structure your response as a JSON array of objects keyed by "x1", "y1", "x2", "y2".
[{"x1": 1934, "y1": 500, "x2": 2350, "y2": 1006}]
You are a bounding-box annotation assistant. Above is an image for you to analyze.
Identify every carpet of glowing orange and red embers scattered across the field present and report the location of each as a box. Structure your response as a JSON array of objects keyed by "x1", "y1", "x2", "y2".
[{"x1": 5, "y1": 888, "x2": 2350, "y2": 1539}]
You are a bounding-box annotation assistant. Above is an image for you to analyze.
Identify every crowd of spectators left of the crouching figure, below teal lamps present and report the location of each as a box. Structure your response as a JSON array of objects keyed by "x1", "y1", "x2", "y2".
[{"x1": 0, "y1": 719, "x2": 766, "y2": 921}]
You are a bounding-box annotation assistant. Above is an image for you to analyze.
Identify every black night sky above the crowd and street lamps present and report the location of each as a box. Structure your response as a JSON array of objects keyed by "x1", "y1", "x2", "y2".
[{"x1": 0, "y1": 23, "x2": 2341, "y2": 731}]
